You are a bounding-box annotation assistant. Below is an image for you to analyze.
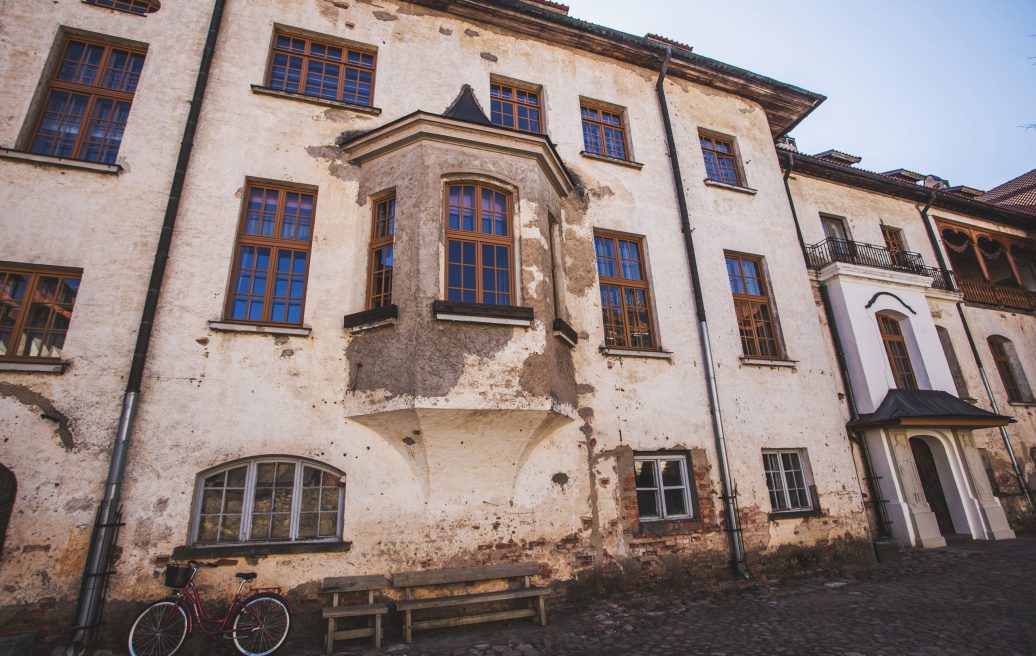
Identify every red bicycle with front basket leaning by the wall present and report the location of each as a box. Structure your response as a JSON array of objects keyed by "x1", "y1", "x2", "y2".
[{"x1": 126, "y1": 561, "x2": 291, "y2": 656}]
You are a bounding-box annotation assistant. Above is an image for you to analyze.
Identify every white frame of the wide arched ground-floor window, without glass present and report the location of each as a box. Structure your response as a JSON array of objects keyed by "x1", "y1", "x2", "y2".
[{"x1": 190, "y1": 456, "x2": 345, "y2": 546}]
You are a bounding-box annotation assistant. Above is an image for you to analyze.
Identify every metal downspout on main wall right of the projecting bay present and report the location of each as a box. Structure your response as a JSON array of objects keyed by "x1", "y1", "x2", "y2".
[{"x1": 655, "y1": 47, "x2": 752, "y2": 578}]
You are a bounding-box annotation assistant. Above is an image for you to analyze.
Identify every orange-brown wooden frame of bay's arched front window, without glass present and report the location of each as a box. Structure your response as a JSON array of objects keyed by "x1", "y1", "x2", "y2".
[{"x1": 442, "y1": 179, "x2": 518, "y2": 307}]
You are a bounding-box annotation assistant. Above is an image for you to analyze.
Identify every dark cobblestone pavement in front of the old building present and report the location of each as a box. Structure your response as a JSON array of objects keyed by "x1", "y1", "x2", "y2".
[{"x1": 314, "y1": 535, "x2": 1036, "y2": 656}]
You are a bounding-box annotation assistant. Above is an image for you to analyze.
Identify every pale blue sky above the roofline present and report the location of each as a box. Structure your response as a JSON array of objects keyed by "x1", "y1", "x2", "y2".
[{"x1": 563, "y1": 0, "x2": 1036, "y2": 190}]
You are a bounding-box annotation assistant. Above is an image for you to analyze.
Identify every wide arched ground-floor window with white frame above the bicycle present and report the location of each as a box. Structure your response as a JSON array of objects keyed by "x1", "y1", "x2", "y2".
[{"x1": 191, "y1": 458, "x2": 345, "y2": 544}]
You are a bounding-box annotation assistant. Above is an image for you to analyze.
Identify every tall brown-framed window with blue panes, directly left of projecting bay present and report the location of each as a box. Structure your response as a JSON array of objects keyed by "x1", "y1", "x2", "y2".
[{"x1": 226, "y1": 183, "x2": 316, "y2": 324}]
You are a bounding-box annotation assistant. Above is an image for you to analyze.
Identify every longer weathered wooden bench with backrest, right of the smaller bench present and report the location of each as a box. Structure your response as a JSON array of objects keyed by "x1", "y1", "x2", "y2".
[{"x1": 392, "y1": 562, "x2": 550, "y2": 644}]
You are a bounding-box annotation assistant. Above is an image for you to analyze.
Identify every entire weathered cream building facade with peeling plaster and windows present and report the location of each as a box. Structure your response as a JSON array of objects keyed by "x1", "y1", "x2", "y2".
[{"x1": 0, "y1": 0, "x2": 1036, "y2": 645}]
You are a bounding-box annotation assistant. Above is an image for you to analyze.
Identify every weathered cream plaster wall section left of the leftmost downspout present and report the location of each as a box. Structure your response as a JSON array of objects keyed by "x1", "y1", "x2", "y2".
[{"x1": 0, "y1": 0, "x2": 208, "y2": 632}]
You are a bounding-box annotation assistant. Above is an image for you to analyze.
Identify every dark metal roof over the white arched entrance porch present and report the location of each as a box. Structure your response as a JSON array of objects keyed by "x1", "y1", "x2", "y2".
[{"x1": 848, "y1": 390, "x2": 1014, "y2": 429}]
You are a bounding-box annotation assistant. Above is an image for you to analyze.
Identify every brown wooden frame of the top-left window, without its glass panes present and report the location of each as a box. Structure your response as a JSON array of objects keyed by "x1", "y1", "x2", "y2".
[{"x1": 25, "y1": 32, "x2": 147, "y2": 165}]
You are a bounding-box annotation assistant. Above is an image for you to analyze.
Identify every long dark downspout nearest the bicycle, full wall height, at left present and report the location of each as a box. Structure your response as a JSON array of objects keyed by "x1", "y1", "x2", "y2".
[{"x1": 65, "y1": 0, "x2": 226, "y2": 656}]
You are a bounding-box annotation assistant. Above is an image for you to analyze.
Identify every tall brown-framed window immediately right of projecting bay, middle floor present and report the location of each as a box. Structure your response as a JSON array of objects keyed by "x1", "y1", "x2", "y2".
[{"x1": 594, "y1": 231, "x2": 658, "y2": 350}]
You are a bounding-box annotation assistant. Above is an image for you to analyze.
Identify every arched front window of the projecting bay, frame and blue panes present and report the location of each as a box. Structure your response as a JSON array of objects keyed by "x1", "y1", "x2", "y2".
[{"x1": 445, "y1": 183, "x2": 514, "y2": 306}]
